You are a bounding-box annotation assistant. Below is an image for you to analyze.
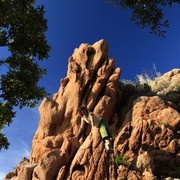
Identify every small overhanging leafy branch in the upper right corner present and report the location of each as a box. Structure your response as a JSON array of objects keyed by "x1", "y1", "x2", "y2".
[{"x1": 106, "y1": 0, "x2": 180, "y2": 37}]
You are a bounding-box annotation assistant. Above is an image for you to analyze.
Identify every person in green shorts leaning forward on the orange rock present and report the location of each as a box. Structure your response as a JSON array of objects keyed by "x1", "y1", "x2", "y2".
[{"x1": 76, "y1": 106, "x2": 113, "y2": 153}]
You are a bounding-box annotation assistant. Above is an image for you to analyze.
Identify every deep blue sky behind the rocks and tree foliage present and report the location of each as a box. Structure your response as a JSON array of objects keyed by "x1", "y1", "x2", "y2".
[{"x1": 0, "y1": 0, "x2": 180, "y2": 179}]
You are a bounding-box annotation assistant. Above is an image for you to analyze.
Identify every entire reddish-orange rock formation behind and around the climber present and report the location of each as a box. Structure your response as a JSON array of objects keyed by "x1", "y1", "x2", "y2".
[{"x1": 5, "y1": 40, "x2": 180, "y2": 180}]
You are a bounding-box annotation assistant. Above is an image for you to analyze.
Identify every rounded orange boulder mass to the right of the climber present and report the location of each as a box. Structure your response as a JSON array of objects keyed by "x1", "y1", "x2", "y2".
[{"x1": 114, "y1": 89, "x2": 180, "y2": 179}]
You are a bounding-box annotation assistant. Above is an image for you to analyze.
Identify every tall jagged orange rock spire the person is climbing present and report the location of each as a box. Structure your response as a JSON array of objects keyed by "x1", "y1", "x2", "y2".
[{"x1": 30, "y1": 40, "x2": 120, "y2": 179}]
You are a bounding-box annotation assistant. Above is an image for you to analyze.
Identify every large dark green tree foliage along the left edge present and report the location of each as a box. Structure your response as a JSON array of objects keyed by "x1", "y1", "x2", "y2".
[{"x1": 0, "y1": 0, "x2": 50, "y2": 149}]
